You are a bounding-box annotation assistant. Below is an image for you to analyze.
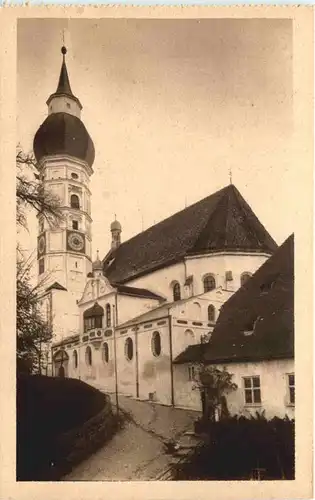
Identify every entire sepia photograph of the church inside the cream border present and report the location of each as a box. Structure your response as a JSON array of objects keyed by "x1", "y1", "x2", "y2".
[{"x1": 8, "y1": 9, "x2": 311, "y2": 490}]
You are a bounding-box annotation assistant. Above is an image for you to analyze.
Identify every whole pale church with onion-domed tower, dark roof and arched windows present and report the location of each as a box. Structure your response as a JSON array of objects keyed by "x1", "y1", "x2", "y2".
[{"x1": 34, "y1": 48, "x2": 284, "y2": 410}]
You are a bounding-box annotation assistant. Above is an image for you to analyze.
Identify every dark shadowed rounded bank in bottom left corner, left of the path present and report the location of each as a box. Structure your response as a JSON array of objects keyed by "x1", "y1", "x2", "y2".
[{"x1": 17, "y1": 375, "x2": 115, "y2": 481}]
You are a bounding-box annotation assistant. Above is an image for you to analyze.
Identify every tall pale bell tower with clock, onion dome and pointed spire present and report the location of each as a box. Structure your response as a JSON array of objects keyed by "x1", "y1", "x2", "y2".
[{"x1": 33, "y1": 47, "x2": 95, "y2": 340}]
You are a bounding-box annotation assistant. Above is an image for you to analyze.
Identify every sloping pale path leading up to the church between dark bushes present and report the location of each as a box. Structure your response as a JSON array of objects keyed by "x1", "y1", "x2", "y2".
[{"x1": 63, "y1": 396, "x2": 199, "y2": 481}]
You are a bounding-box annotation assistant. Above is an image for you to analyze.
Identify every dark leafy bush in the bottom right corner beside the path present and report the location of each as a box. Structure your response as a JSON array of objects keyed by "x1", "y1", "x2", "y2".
[{"x1": 176, "y1": 416, "x2": 294, "y2": 480}]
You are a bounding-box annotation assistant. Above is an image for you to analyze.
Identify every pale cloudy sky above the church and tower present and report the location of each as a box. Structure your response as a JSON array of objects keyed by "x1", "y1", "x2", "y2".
[{"x1": 17, "y1": 19, "x2": 298, "y2": 262}]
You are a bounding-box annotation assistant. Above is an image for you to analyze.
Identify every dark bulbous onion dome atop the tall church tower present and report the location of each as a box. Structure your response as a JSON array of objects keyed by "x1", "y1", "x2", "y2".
[{"x1": 33, "y1": 113, "x2": 95, "y2": 167}]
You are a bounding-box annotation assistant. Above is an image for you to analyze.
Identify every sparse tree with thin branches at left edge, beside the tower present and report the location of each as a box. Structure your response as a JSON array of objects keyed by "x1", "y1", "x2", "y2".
[{"x1": 16, "y1": 147, "x2": 63, "y2": 373}]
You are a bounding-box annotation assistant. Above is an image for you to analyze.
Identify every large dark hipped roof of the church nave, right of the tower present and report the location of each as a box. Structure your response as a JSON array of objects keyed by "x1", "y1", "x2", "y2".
[{"x1": 104, "y1": 184, "x2": 277, "y2": 283}]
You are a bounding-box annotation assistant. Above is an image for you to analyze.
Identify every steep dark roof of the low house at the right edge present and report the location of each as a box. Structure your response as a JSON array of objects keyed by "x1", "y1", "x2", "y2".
[{"x1": 175, "y1": 235, "x2": 294, "y2": 364}]
